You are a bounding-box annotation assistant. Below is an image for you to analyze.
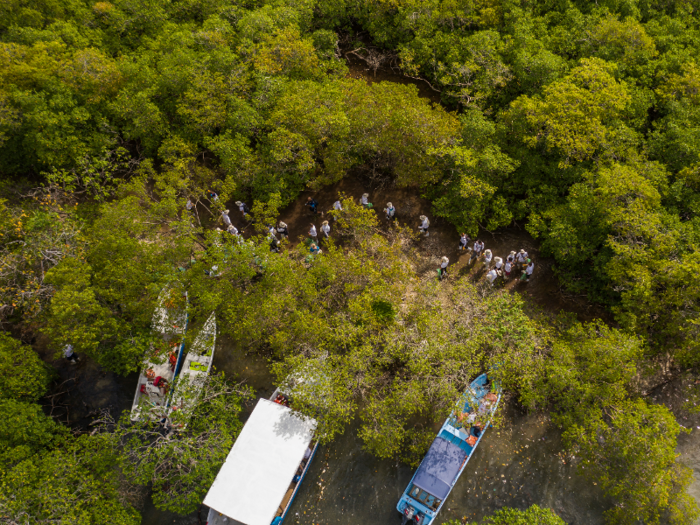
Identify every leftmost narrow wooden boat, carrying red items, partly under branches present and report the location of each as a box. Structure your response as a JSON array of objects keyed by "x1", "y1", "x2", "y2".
[{"x1": 131, "y1": 282, "x2": 187, "y2": 421}]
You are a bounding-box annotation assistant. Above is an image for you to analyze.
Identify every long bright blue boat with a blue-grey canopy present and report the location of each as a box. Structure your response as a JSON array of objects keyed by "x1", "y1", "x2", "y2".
[{"x1": 396, "y1": 374, "x2": 501, "y2": 525}]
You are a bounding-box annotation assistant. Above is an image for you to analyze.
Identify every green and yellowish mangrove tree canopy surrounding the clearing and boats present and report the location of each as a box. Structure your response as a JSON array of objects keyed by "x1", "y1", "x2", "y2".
[{"x1": 0, "y1": 0, "x2": 700, "y2": 523}]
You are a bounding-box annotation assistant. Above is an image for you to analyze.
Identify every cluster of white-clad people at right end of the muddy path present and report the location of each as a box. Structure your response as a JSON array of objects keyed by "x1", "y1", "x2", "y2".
[{"x1": 438, "y1": 237, "x2": 535, "y2": 286}]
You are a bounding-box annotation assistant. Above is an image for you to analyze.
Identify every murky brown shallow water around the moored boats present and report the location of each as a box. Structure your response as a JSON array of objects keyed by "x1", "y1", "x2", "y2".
[{"x1": 135, "y1": 332, "x2": 608, "y2": 525}]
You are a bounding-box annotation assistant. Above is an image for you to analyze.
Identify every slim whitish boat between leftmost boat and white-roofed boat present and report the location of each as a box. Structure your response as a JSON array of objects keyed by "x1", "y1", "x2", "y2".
[{"x1": 168, "y1": 312, "x2": 216, "y2": 430}]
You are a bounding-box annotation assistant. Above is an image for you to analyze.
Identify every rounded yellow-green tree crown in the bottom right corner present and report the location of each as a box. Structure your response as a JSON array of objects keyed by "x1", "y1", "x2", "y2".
[{"x1": 564, "y1": 400, "x2": 698, "y2": 525}]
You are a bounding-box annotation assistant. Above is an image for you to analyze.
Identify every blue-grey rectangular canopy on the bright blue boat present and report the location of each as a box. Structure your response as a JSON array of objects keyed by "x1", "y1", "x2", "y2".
[{"x1": 413, "y1": 437, "x2": 467, "y2": 499}]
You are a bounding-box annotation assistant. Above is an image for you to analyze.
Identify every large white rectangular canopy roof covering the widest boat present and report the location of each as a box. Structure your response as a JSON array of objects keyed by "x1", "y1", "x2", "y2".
[{"x1": 204, "y1": 399, "x2": 316, "y2": 525}]
